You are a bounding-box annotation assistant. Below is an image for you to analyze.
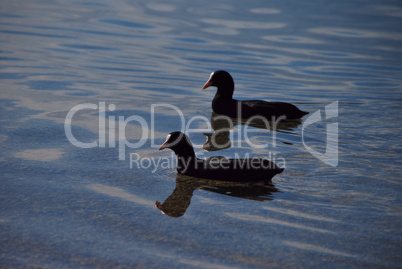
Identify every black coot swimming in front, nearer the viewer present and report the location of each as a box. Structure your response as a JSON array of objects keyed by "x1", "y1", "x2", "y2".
[{"x1": 159, "y1": 131, "x2": 284, "y2": 184}]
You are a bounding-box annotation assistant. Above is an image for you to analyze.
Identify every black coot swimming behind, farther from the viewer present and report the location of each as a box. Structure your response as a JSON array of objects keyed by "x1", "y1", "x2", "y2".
[{"x1": 202, "y1": 70, "x2": 308, "y2": 120}]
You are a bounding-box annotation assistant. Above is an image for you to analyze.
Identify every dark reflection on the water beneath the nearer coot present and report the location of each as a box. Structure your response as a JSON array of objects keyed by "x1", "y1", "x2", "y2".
[{"x1": 155, "y1": 174, "x2": 279, "y2": 218}]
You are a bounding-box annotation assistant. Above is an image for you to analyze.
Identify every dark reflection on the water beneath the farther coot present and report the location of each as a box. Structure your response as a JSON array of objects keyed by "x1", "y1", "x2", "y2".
[{"x1": 202, "y1": 112, "x2": 302, "y2": 151}]
